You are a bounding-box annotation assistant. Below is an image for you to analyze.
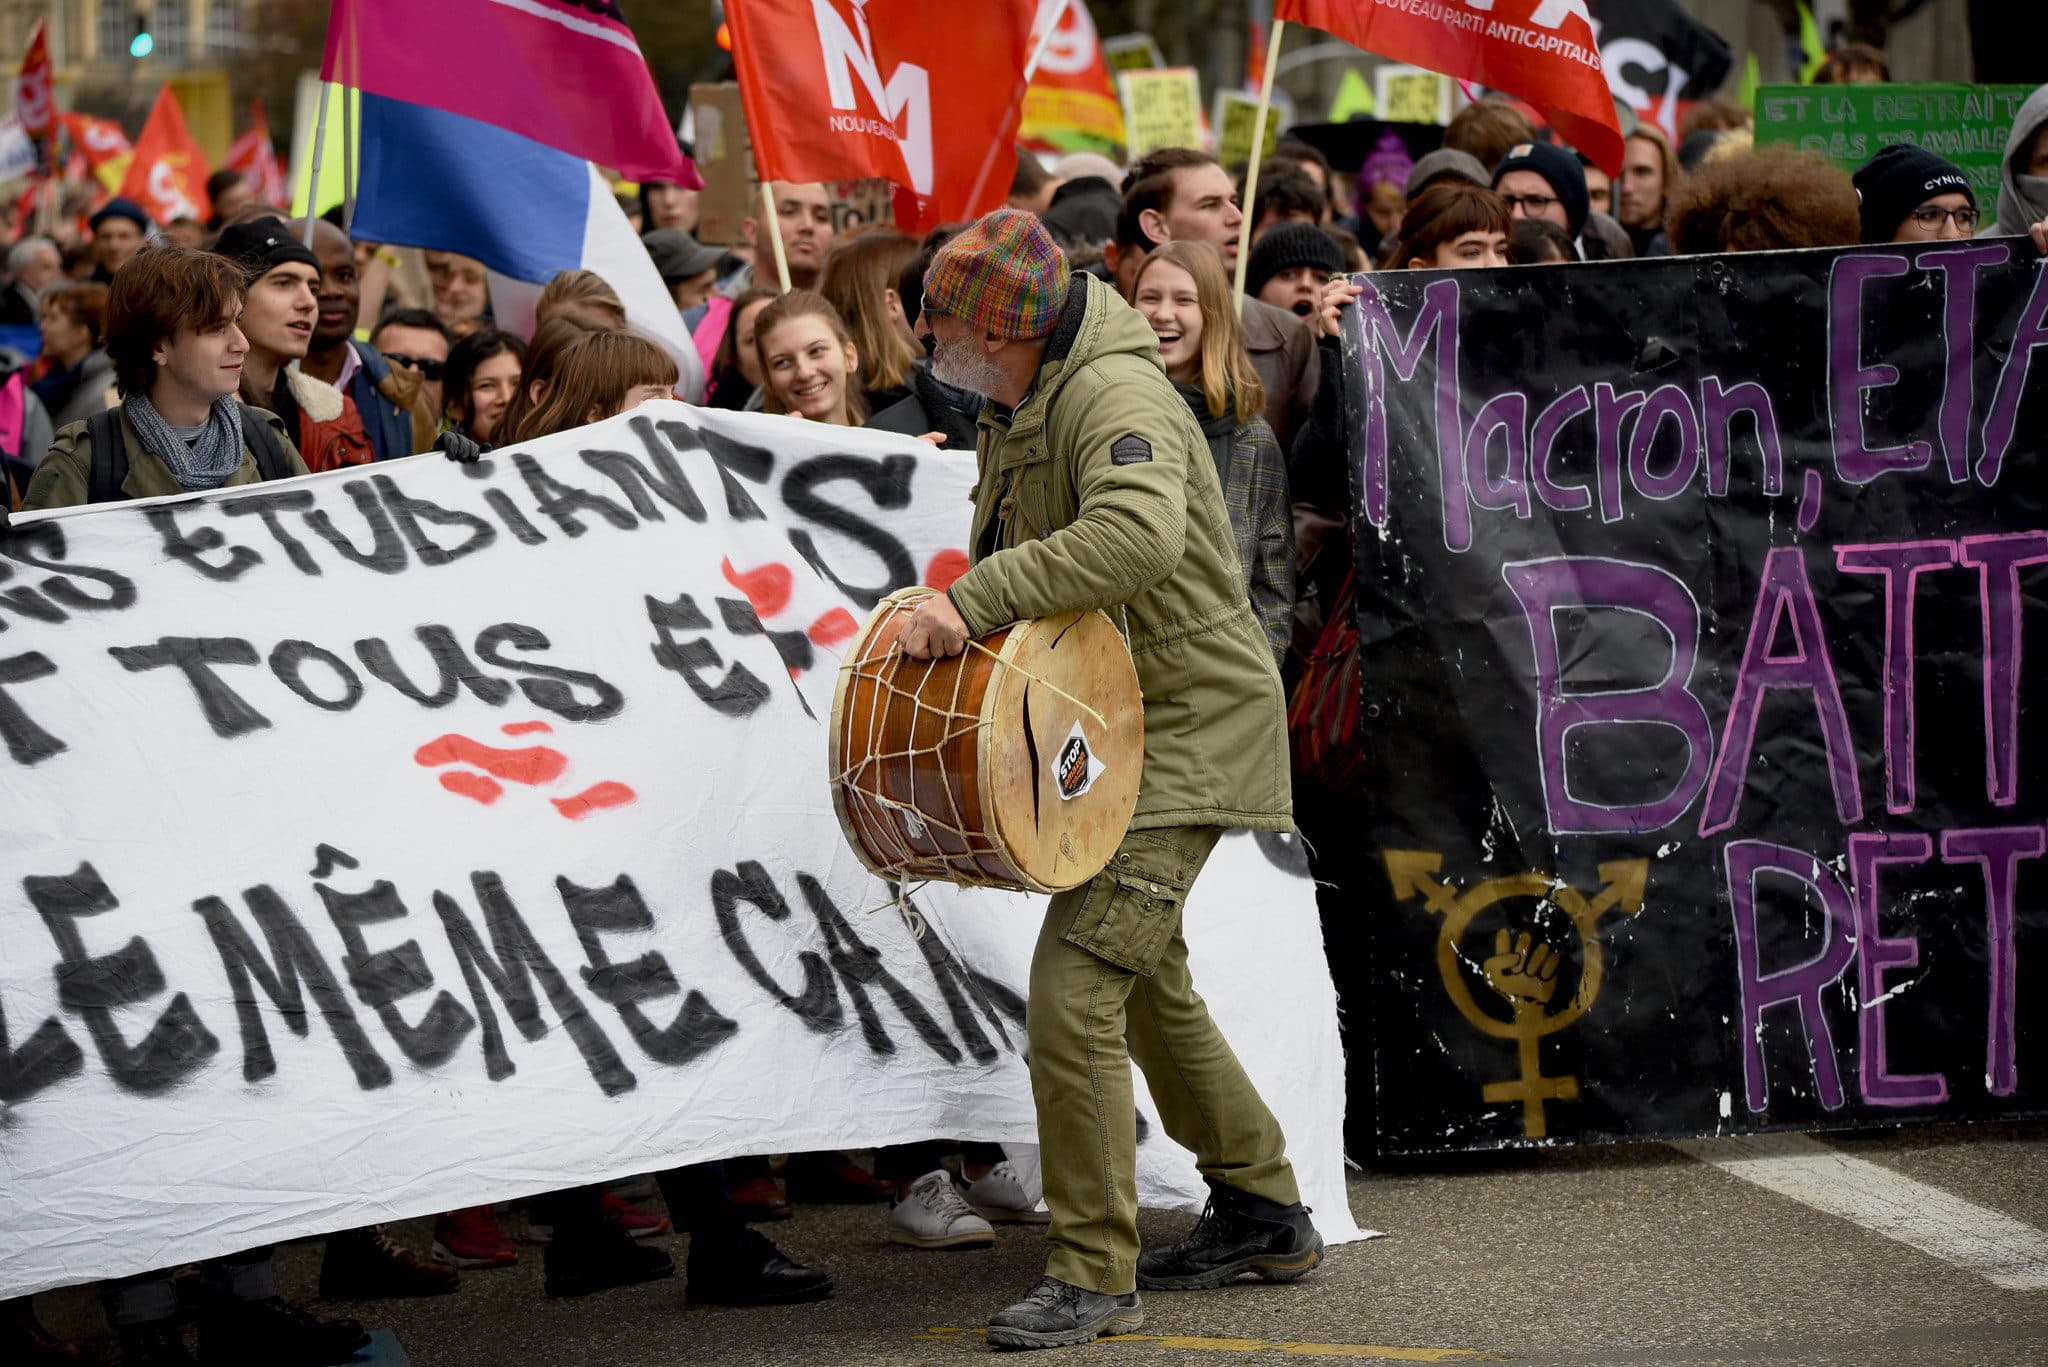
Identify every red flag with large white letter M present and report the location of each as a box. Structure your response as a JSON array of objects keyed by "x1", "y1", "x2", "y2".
[{"x1": 725, "y1": 0, "x2": 1036, "y2": 234}]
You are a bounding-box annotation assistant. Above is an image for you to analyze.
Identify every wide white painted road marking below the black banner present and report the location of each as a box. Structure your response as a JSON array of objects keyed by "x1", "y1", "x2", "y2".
[{"x1": 1671, "y1": 1133, "x2": 2048, "y2": 1291}]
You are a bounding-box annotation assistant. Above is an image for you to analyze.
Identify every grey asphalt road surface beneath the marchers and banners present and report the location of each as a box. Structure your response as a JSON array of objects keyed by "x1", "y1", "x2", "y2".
[{"x1": 41, "y1": 1125, "x2": 2048, "y2": 1367}]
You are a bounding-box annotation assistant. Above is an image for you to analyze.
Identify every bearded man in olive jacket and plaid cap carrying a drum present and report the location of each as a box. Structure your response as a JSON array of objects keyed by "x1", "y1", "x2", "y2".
[{"x1": 903, "y1": 209, "x2": 1323, "y2": 1349}]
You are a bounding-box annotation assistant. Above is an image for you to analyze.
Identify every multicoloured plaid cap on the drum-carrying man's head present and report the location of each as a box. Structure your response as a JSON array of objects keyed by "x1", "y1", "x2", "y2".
[{"x1": 924, "y1": 209, "x2": 1067, "y2": 340}]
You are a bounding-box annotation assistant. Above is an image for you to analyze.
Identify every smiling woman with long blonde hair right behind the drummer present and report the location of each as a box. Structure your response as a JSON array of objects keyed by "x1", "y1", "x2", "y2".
[{"x1": 1130, "y1": 242, "x2": 1294, "y2": 664}]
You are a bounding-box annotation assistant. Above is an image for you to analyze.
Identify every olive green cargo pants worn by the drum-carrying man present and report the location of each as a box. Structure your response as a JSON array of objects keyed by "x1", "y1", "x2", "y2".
[{"x1": 1026, "y1": 826, "x2": 1300, "y2": 1295}]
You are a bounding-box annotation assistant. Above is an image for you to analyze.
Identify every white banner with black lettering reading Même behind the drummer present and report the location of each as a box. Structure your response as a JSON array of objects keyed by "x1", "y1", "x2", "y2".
[{"x1": 0, "y1": 402, "x2": 1358, "y2": 1295}]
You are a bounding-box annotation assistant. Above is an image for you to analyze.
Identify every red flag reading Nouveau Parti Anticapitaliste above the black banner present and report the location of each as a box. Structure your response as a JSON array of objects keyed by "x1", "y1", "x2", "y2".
[{"x1": 1274, "y1": 0, "x2": 1622, "y2": 176}]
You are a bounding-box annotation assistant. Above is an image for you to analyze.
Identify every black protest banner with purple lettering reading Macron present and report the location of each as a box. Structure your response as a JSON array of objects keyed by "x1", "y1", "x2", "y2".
[{"x1": 1350, "y1": 240, "x2": 2048, "y2": 1152}]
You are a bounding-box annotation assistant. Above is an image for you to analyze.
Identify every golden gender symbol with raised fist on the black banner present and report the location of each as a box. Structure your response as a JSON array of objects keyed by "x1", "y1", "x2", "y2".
[{"x1": 1380, "y1": 851, "x2": 1651, "y2": 1140}]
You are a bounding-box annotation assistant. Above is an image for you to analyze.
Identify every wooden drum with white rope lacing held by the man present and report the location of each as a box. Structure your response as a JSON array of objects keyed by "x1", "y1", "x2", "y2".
[{"x1": 831, "y1": 588, "x2": 1145, "y2": 892}]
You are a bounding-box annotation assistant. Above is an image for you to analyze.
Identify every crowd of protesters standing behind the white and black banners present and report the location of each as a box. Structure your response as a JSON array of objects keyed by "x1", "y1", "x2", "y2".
[{"x1": 0, "y1": 49, "x2": 2048, "y2": 1367}]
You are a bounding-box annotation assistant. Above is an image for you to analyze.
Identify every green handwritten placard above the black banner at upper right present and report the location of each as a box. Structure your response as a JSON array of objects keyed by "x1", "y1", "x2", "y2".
[{"x1": 1757, "y1": 84, "x2": 2034, "y2": 200}]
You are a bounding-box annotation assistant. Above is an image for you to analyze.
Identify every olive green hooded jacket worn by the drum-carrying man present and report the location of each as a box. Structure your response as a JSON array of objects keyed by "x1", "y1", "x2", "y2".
[{"x1": 950, "y1": 275, "x2": 1294, "y2": 830}]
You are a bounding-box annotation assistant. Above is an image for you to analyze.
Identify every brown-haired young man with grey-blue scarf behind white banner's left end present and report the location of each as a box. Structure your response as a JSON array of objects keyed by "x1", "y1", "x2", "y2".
[{"x1": 20, "y1": 246, "x2": 305, "y2": 512}]
